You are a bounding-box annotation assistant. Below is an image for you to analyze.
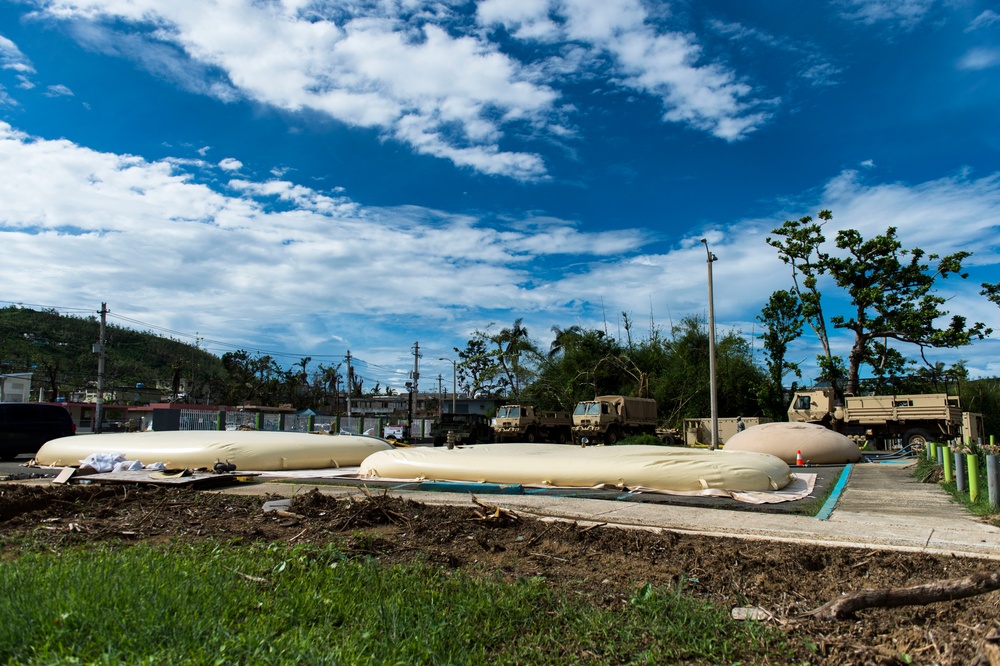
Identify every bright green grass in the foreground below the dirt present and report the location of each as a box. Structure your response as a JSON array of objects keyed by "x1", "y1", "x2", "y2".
[{"x1": 0, "y1": 544, "x2": 792, "y2": 664}]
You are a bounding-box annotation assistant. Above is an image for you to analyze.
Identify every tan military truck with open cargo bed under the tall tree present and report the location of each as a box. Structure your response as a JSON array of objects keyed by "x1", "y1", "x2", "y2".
[{"x1": 788, "y1": 388, "x2": 982, "y2": 449}]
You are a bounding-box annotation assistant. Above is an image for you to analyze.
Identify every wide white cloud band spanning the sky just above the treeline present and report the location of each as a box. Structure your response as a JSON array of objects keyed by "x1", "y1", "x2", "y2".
[{"x1": 0, "y1": 124, "x2": 1000, "y2": 376}]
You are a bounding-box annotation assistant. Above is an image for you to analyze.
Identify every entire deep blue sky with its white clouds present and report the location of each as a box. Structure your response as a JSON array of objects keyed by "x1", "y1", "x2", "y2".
[{"x1": 0, "y1": 0, "x2": 1000, "y2": 388}]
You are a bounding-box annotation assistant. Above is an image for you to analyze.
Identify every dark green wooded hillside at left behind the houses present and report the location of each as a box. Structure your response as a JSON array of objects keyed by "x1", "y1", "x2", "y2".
[{"x1": 0, "y1": 306, "x2": 225, "y2": 400}]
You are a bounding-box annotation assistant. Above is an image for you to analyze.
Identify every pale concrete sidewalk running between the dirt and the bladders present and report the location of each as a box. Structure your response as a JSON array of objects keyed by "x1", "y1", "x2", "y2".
[{"x1": 213, "y1": 463, "x2": 1000, "y2": 560}]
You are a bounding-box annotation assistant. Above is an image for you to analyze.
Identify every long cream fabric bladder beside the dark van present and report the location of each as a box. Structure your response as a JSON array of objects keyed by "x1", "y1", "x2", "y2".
[{"x1": 35, "y1": 430, "x2": 392, "y2": 471}]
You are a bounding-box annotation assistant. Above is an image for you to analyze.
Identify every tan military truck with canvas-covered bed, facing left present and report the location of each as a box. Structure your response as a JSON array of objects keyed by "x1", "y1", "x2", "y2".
[{"x1": 573, "y1": 395, "x2": 656, "y2": 445}]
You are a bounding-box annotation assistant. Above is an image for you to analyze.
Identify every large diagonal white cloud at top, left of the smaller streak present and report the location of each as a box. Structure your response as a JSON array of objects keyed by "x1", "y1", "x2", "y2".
[{"x1": 29, "y1": 0, "x2": 557, "y2": 180}]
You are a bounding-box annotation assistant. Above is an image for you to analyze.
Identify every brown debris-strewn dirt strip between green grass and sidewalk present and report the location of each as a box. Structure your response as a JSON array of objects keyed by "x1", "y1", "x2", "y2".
[{"x1": 0, "y1": 483, "x2": 1000, "y2": 665}]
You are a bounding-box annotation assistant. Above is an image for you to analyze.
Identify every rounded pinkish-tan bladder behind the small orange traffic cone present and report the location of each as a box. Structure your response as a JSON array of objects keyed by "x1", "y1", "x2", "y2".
[{"x1": 723, "y1": 423, "x2": 861, "y2": 465}]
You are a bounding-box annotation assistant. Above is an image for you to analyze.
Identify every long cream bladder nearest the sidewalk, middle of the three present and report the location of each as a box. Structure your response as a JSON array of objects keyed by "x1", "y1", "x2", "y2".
[{"x1": 359, "y1": 444, "x2": 790, "y2": 491}]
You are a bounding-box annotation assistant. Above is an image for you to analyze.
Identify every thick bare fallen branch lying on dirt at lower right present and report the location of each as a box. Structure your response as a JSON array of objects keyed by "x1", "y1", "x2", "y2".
[{"x1": 803, "y1": 571, "x2": 1000, "y2": 620}]
